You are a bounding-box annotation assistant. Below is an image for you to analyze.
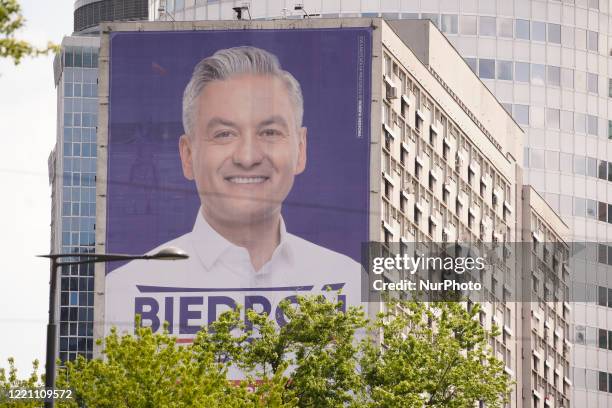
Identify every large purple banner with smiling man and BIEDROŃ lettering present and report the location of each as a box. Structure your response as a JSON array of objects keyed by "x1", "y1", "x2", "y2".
[{"x1": 105, "y1": 28, "x2": 372, "y2": 341}]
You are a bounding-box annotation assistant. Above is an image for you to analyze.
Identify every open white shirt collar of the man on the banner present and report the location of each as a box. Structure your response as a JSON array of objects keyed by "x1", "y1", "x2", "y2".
[{"x1": 191, "y1": 207, "x2": 294, "y2": 271}]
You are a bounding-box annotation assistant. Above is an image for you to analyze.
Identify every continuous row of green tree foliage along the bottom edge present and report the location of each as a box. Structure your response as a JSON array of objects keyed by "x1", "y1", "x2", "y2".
[{"x1": 0, "y1": 296, "x2": 512, "y2": 408}]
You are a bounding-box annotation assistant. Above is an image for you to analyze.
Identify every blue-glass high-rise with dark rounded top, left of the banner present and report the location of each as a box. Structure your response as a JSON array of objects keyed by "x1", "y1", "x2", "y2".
[{"x1": 49, "y1": 0, "x2": 148, "y2": 361}]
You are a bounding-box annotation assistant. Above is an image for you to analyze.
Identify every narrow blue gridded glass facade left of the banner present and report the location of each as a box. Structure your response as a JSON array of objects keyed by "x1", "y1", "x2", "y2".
[{"x1": 55, "y1": 46, "x2": 98, "y2": 362}]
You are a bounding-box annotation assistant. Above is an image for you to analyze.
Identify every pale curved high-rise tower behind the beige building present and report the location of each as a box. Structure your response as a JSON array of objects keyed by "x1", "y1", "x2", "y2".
[{"x1": 149, "y1": 0, "x2": 612, "y2": 408}]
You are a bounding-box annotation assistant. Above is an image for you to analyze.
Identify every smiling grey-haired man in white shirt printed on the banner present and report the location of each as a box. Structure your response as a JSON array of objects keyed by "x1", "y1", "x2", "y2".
[{"x1": 105, "y1": 47, "x2": 361, "y2": 341}]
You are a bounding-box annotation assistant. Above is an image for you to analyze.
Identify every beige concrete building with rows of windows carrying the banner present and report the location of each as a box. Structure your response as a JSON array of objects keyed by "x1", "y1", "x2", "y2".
[{"x1": 88, "y1": 19, "x2": 571, "y2": 407}]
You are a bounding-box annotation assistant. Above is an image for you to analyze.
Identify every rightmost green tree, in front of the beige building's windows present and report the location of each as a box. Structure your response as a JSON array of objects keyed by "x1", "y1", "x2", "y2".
[{"x1": 361, "y1": 302, "x2": 512, "y2": 408}]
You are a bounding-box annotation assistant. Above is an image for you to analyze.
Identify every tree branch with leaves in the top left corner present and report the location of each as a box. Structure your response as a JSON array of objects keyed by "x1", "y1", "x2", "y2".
[{"x1": 0, "y1": 0, "x2": 59, "y2": 65}]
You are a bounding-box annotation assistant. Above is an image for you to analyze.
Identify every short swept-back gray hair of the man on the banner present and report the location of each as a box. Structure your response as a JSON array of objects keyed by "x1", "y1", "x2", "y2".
[{"x1": 183, "y1": 46, "x2": 304, "y2": 135}]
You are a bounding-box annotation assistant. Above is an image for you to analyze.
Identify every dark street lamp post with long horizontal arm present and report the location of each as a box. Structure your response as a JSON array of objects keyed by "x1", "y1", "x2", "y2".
[{"x1": 38, "y1": 247, "x2": 189, "y2": 408}]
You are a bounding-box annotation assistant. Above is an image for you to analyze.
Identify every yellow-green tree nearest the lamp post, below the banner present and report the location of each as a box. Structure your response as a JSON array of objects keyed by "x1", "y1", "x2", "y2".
[{"x1": 57, "y1": 322, "x2": 284, "y2": 408}]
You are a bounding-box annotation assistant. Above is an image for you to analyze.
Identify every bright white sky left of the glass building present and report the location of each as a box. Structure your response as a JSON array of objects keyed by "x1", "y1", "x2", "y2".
[{"x1": 0, "y1": 0, "x2": 74, "y2": 377}]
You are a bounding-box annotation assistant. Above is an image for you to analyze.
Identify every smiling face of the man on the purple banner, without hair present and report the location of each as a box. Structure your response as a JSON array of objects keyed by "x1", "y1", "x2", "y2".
[{"x1": 180, "y1": 74, "x2": 306, "y2": 228}]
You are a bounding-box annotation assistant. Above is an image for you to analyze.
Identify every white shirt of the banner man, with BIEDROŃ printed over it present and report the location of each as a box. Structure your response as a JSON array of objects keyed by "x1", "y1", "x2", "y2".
[{"x1": 105, "y1": 211, "x2": 362, "y2": 342}]
